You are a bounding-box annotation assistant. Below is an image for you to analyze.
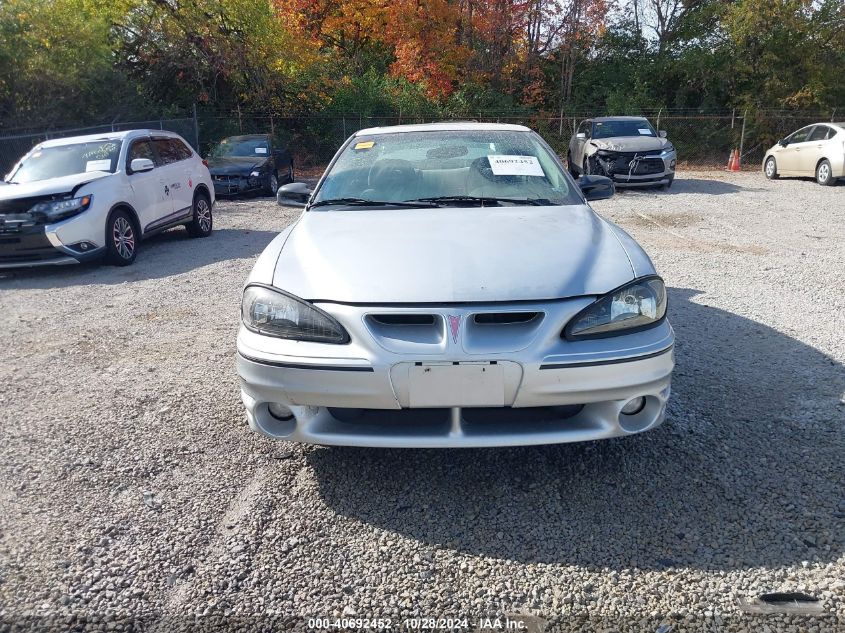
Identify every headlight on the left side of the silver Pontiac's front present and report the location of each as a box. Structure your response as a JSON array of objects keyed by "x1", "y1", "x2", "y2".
[{"x1": 241, "y1": 286, "x2": 349, "y2": 344}]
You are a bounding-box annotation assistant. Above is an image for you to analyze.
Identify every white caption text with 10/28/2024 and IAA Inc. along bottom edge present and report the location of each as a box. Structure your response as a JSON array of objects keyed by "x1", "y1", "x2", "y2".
[{"x1": 308, "y1": 616, "x2": 534, "y2": 633}]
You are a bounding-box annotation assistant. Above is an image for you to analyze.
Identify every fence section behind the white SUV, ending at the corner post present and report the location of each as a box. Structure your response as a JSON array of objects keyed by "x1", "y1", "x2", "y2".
[{"x1": 0, "y1": 118, "x2": 199, "y2": 178}]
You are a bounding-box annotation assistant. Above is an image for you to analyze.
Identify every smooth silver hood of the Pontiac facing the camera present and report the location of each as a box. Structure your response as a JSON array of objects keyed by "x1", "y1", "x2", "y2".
[{"x1": 273, "y1": 205, "x2": 634, "y2": 303}]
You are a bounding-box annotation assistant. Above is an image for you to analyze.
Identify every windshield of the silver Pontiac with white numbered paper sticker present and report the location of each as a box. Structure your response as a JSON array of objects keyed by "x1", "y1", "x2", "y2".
[{"x1": 312, "y1": 130, "x2": 581, "y2": 208}]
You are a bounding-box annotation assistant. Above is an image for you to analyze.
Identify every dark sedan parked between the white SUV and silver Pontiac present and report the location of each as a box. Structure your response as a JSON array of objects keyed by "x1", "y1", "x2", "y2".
[{"x1": 208, "y1": 134, "x2": 293, "y2": 196}]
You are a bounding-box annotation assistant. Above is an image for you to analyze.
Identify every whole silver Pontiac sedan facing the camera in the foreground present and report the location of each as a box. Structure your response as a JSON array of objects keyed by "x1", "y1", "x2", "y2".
[{"x1": 237, "y1": 123, "x2": 674, "y2": 447}]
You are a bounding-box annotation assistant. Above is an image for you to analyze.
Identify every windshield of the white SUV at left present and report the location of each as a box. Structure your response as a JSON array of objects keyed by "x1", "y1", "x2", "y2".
[{"x1": 8, "y1": 140, "x2": 121, "y2": 183}]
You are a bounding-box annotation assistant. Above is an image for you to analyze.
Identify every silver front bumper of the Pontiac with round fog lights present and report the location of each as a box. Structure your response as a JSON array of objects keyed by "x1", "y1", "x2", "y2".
[{"x1": 237, "y1": 299, "x2": 674, "y2": 448}]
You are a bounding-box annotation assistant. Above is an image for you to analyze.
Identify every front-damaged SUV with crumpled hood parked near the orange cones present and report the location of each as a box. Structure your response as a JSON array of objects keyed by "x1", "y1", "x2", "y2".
[{"x1": 566, "y1": 116, "x2": 678, "y2": 188}]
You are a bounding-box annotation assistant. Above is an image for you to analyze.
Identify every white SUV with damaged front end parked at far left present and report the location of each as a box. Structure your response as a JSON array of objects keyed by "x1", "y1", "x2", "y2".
[{"x1": 0, "y1": 130, "x2": 214, "y2": 268}]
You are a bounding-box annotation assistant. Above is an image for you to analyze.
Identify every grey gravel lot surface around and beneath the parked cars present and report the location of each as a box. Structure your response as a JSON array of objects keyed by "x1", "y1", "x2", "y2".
[{"x1": 0, "y1": 172, "x2": 845, "y2": 633}]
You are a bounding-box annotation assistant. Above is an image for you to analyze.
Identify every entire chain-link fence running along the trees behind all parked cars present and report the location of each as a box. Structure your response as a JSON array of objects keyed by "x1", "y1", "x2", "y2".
[{"x1": 0, "y1": 108, "x2": 845, "y2": 174}]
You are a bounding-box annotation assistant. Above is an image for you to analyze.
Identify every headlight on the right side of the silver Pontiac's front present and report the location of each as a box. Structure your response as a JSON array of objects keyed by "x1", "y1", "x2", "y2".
[{"x1": 563, "y1": 276, "x2": 666, "y2": 339}]
